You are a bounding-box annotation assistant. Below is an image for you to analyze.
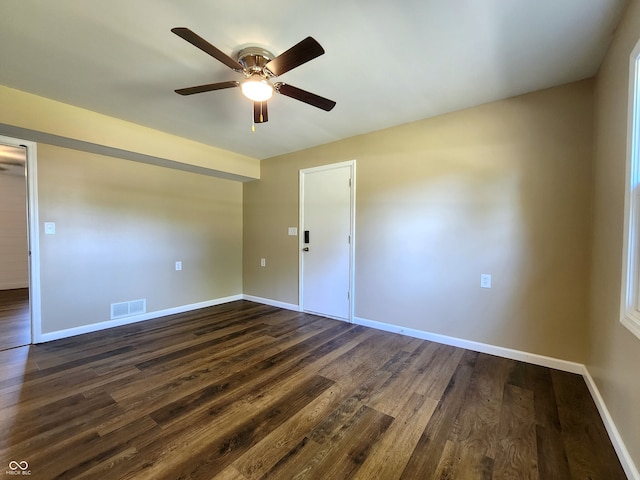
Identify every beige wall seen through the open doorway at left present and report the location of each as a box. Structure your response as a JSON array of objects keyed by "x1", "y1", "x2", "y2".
[{"x1": 0, "y1": 165, "x2": 29, "y2": 290}]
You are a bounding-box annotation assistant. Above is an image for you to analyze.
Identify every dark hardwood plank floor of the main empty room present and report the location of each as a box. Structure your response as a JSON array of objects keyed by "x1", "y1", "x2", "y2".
[{"x1": 0, "y1": 301, "x2": 625, "y2": 480}]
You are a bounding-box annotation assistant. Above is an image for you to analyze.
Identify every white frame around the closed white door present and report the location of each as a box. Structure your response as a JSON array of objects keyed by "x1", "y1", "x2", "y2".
[{"x1": 298, "y1": 160, "x2": 356, "y2": 323}]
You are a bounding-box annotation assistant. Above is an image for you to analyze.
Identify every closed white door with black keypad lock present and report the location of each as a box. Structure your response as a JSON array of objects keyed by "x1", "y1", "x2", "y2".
[{"x1": 300, "y1": 161, "x2": 355, "y2": 320}]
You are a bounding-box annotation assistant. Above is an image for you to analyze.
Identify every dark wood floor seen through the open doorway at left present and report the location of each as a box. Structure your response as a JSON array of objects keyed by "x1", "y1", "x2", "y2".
[{"x1": 0, "y1": 288, "x2": 31, "y2": 350}]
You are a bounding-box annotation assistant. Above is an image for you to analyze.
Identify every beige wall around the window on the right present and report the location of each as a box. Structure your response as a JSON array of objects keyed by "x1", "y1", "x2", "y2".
[{"x1": 587, "y1": 2, "x2": 640, "y2": 466}]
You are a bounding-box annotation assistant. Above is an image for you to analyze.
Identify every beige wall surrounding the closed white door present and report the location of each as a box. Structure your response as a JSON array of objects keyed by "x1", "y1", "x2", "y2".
[{"x1": 243, "y1": 81, "x2": 593, "y2": 361}]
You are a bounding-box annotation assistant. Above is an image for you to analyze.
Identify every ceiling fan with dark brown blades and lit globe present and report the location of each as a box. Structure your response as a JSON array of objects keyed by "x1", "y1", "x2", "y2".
[{"x1": 171, "y1": 27, "x2": 336, "y2": 123}]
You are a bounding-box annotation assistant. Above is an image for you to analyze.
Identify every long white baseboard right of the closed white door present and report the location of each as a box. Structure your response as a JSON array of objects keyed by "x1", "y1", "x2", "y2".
[{"x1": 353, "y1": 317, "x2": 584, "y2": 375}]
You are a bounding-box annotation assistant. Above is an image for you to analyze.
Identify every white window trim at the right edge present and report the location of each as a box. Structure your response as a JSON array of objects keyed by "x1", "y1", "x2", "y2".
[{"x1": 620, "y1": 35, "x2": 640, "y2": 339}]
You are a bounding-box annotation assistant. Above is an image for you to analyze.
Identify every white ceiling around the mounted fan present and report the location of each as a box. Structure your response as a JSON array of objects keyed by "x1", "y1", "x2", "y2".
[{"x1": 0, "y1": 0, "x2": 627, "y2": 159}]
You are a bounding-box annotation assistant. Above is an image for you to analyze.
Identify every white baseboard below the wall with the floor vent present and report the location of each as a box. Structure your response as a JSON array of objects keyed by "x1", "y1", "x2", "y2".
[{"x1": 33, "y1": 295, "x2": 243, "y2": 343}]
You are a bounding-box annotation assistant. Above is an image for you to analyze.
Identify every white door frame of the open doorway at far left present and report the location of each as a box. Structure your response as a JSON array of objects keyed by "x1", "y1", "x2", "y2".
[{"x1": 0, "y1": 135, "x2": 42, "y2": 343}]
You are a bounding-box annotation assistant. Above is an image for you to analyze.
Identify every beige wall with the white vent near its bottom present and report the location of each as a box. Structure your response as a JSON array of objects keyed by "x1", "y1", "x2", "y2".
[{"x1": 38, "y1": 144, "x2": 242, "y2": 333}]
